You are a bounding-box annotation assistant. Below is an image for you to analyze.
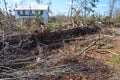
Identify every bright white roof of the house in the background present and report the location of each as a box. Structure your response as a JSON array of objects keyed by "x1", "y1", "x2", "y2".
[{"x1": 15, "y1": 4, "x2": 49, "y2": 10}]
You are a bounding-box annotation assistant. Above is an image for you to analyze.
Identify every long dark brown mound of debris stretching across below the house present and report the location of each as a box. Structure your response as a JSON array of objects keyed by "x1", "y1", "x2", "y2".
[{"x1": 0, "y1": 27, "x2": 100, "y2": 50}]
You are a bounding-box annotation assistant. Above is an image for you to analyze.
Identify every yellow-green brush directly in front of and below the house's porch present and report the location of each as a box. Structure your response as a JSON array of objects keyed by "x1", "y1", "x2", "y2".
[{"x1": 16, "y1": 11, "x2": 44, "y2": 31}]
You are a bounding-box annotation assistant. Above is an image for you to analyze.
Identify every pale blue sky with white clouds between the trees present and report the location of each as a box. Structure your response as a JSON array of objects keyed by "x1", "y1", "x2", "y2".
[{"x1": 0, "y1": 0, "x2": 119, "y2": 15}]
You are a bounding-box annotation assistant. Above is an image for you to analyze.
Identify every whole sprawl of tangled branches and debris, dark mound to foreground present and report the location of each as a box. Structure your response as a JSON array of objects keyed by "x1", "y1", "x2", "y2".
[{"x1": 0, "y1": 27, "x2": 118, "y2": 80}]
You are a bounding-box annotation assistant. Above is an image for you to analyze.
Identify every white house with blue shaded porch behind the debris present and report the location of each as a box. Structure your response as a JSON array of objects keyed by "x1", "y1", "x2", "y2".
[{"x1": 15, "y1": 4, "x2": 49, "y2": 23}]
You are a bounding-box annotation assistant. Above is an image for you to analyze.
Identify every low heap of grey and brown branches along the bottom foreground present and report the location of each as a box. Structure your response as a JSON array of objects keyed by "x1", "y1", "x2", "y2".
[{"x1": 0, "y1": 57, "x2": 115, "y2": 80}]
